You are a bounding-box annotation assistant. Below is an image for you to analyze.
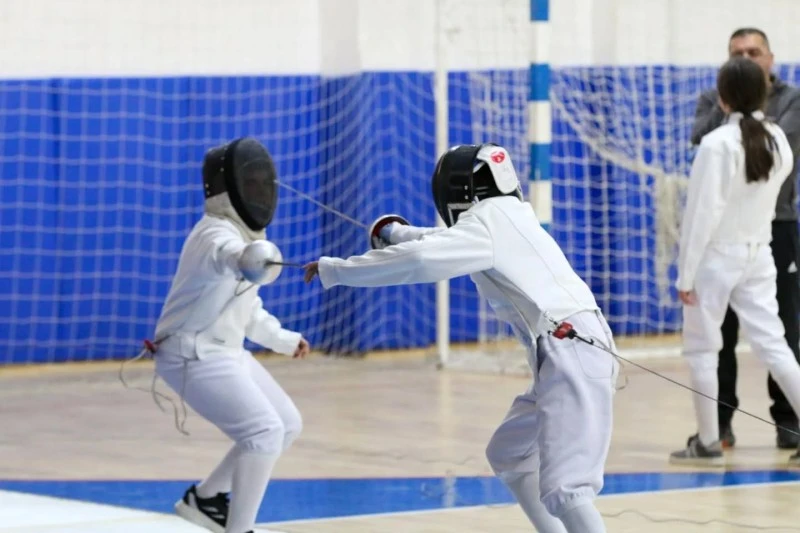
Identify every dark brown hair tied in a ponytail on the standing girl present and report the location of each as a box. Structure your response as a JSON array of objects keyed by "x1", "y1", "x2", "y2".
[{"x1": 717, "y1": 57, "x2": 777, "y2": 183}]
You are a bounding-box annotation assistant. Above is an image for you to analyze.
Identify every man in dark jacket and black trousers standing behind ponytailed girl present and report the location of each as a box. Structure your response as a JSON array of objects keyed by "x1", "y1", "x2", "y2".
[{"x1": 692, "y1": 28, "x2": 800, "y2": 450}]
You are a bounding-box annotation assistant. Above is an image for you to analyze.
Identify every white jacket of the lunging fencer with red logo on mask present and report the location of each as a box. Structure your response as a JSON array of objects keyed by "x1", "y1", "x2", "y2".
[{"x1": 319, "y1": 196, "x2": 598, "y2": 348}]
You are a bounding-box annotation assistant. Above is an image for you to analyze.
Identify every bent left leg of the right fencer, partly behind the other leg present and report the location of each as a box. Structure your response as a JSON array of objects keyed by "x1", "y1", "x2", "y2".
[{"x1": 486, "y1": 392, "x2": 567, "y2": 533}]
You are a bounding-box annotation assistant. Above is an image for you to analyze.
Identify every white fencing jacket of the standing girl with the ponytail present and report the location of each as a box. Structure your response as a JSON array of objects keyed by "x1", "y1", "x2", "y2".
[{"x1": 677, "y1": 112, "x2": 794, "y2": 291}]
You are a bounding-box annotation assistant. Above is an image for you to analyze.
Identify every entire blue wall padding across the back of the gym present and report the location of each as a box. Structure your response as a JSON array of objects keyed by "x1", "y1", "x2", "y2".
[{"x1": 9, "y1": 63, "x2": 788, "y2": 363}]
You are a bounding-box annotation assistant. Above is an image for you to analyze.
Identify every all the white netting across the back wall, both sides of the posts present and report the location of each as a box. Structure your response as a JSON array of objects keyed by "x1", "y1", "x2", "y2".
[{"x1": 0, "y1": 0, "x2": 800, "y2": 372}]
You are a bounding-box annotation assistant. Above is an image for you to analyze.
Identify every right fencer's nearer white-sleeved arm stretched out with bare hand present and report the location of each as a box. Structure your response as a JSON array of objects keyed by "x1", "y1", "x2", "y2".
[{"x1": 319, "y1": 213, "x2": 494, "y2": 289}]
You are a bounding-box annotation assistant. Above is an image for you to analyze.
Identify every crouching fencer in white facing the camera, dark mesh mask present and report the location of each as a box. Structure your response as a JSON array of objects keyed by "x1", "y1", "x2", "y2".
[{"x1": 154, "y1": 138, "x2": 309, "y2": 533}]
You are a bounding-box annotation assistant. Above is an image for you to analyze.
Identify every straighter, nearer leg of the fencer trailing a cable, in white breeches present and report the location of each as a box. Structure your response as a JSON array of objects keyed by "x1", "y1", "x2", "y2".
[{"x1": 535, "y1": 312, "x2": 618, "y2": 533}]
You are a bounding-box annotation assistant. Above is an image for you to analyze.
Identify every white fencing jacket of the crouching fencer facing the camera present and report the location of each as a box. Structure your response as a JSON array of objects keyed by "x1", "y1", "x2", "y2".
[{"x1": 156, "y1": 214, "x2": 301, "y2": 359}]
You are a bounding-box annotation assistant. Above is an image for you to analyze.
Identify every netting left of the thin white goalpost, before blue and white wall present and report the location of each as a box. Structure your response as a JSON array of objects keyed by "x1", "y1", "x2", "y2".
[{"x1": 0, "y1": 0, "x2": 436, "y2": 364}]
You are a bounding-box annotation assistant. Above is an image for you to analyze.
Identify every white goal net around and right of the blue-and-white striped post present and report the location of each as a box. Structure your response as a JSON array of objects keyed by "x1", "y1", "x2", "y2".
[{"x1": 448, "y1": 0, "x2": 800, "y2": 373}]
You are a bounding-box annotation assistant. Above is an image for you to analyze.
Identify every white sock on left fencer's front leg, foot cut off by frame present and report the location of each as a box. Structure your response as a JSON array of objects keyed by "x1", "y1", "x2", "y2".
[{"x1": 225, "y1": 451, "x2": 279, "y2": 533}]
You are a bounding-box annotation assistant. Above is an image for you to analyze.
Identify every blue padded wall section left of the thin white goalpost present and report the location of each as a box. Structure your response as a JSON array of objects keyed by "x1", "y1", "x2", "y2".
[{"x1": 0, "y1": 73, "x2": 435, "y2": 363}]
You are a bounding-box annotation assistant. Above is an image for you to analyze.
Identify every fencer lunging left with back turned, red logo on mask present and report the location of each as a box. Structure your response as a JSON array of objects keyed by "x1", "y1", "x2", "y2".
[{"x1": 305, "y1": 144, "x2": 617, "y2": 533}]
